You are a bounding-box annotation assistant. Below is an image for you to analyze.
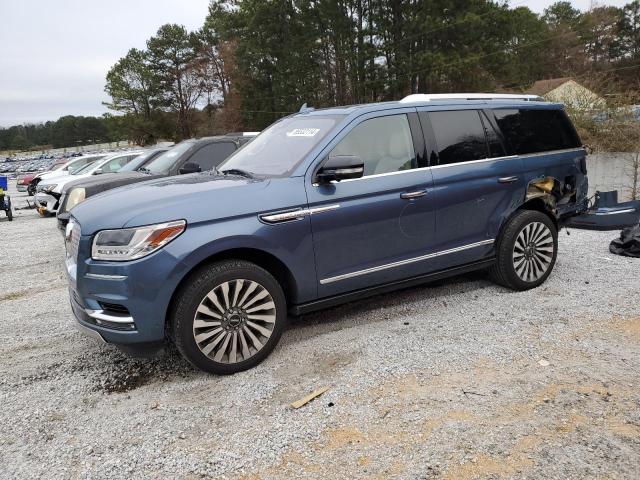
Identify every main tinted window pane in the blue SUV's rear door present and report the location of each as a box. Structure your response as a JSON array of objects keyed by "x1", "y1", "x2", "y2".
[{"x1": 429, "y1": 110, "x2": 489, "y2": 165}]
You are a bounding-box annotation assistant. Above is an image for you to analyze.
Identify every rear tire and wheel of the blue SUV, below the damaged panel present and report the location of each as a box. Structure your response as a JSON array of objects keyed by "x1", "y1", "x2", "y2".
[{"x1": 490, "y1": 210, "x2": 558, "y2": 290}]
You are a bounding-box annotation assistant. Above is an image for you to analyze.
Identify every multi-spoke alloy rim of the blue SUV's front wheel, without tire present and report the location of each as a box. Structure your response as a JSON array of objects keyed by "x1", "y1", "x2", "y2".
[{"x1": 193, "y1": 279, "x2": 276, "y2": 364}]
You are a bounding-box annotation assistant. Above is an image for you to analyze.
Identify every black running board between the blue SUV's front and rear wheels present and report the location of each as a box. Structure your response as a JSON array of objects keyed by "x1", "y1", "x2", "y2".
[{"x1": 289, "y1": 257, "x2": 495, "y2": 316}]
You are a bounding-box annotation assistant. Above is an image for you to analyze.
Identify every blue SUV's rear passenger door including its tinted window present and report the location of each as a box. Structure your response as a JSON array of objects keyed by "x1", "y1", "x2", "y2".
[{"x1": 420, "y1": 109, "x2": 525, "y2": 268}]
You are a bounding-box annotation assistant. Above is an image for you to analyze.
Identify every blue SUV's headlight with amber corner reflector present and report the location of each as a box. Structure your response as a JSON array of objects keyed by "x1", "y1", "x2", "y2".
[{"x1": 91, "y1": 220, "x2": 187, "y2": 262}]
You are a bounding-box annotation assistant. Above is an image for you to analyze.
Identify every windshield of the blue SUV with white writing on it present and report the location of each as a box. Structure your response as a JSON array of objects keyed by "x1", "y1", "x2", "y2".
[{"x1": 218, "y1": 115, "x2": 344, "y2": 177}]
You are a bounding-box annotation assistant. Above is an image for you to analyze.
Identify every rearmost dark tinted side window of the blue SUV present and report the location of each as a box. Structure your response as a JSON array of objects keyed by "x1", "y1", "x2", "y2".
[{"x1": 494, "y1": 109, "x2": 581, "y2": 155}]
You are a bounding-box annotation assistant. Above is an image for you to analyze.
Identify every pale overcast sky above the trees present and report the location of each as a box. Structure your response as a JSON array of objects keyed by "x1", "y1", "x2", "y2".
[{"x1": 0, "y1": 0, "x2": 630, "y2": 127}]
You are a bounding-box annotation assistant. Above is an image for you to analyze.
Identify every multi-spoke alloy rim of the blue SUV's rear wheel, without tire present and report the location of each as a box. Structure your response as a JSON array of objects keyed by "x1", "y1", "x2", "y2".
[{"x1": 513, "y1": 222, "x2": 555, "y2": 282}]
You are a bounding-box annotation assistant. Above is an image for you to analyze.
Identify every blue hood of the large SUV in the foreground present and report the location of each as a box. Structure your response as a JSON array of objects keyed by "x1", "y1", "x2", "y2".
[{"x1": 73, "y1": 173, "x2": 306, "y2": 235}]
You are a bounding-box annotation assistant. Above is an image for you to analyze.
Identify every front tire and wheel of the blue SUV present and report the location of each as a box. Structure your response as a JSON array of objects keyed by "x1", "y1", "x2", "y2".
[{"x1": 170, "y1": 260, "x2": 287, "y2": 375}]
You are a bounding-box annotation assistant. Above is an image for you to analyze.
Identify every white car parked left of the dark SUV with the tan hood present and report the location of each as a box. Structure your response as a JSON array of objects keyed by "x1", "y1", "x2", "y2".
[{"x1": 35, "y1": 150, "x2": 143, "y2": 216}]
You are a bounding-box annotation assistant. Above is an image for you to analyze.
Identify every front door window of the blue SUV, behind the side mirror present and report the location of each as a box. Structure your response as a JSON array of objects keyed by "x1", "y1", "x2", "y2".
[{"x1": 329, "y1": 114, "x2": 417, "y2": 176}]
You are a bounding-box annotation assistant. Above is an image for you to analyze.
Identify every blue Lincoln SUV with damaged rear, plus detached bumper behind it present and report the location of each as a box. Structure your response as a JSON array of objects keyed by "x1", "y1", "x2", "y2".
[{"x1": 65, "y1": 94, "x2": 640, "y2": 374}]
